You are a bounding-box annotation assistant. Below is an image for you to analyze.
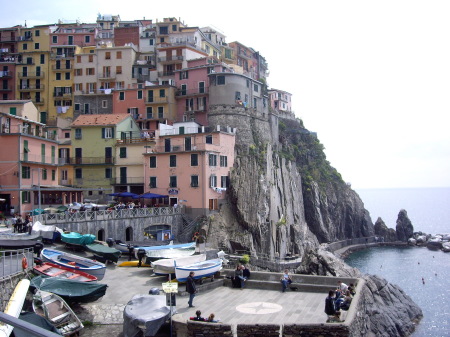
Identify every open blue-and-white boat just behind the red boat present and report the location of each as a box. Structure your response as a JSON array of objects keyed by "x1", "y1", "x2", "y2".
[{"x1": 41, "y1": 248, "x2": 106, "y2": 280}]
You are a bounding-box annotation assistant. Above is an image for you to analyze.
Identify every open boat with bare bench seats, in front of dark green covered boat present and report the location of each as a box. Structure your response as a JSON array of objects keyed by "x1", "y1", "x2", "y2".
[{"x1": 32, "y1": 291, "x2": 84, "y2": 336}]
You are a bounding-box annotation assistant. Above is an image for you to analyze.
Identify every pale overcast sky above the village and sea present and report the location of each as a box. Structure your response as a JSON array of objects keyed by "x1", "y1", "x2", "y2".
[{"x1": 0, "y1": 0, "x2": 450, "y2": 189}]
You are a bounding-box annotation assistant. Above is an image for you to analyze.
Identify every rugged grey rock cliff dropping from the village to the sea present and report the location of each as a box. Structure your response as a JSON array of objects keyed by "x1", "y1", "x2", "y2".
[{"x1": 203, "y1": 105, "x2": 422, "y2": 336}]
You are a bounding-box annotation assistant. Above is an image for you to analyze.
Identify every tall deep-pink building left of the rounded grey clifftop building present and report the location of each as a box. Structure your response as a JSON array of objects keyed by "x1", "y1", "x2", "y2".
[{"x1": 175, "y1": 57, "x2": 231, "y2": 125}]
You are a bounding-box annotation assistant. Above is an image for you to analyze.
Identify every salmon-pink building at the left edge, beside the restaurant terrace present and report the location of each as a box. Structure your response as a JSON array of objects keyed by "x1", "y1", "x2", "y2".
[{"x1": 0, "y1": 101, "x2": 81, "y2": 215}]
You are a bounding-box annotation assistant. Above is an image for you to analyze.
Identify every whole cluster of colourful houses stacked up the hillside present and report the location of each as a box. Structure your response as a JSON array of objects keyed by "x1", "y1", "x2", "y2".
[{"x1": 0, "y1": 14, "x2": 294, "y2": 214}]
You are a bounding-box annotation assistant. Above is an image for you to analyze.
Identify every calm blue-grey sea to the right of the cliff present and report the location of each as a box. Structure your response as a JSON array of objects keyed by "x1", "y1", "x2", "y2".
[{"x1": 346, "y1": 188, "x2": 450, "y2": 337}]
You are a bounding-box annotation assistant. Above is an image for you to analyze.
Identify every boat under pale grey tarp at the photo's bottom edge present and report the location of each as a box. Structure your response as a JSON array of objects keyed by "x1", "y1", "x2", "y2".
[{"x1": 123, "y1": 295, "x2": 176, "y2": 336}]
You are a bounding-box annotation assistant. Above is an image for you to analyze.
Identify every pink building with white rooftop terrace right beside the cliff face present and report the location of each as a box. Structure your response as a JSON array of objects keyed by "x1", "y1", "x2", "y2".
[{"x1": 144, "y1": 122, "x2": 236, "y2": 215}]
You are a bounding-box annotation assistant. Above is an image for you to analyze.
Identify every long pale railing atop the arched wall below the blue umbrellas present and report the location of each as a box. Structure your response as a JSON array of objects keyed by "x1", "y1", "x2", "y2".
[{"x1": 33, "y1": 207, "x2": 182, "y2": 224}]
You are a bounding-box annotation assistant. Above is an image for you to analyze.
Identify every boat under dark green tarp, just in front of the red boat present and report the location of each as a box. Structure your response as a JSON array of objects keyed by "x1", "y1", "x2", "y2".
[{"x1": 30, "y1": 275, "x2": 108, "y2": 303}]
